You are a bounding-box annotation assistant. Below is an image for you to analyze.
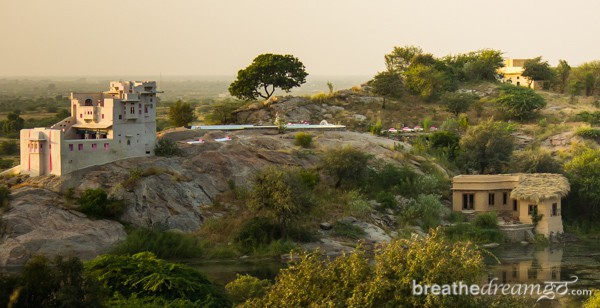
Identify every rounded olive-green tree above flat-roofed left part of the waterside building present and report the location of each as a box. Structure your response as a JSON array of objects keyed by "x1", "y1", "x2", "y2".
[{"x1": 459, "y1": 119, "x2": 514, "y2": 174}]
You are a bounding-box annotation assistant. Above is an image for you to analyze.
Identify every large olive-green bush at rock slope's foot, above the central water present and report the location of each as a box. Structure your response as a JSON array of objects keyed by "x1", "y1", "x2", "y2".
[{"x1": 248, "y1": 166, "x2": 313, "y2": 239}]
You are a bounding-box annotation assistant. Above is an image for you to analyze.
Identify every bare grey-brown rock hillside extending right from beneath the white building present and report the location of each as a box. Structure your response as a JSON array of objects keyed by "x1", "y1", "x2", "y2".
[{"x1": 0, "y1": 129, "x2": 434, "y2": 266}]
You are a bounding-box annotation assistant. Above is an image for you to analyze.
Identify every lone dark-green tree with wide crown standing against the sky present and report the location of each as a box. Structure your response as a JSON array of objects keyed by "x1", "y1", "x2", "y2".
[{"x1": 229, "y1": 53, "x2": 308, "y2": 100}]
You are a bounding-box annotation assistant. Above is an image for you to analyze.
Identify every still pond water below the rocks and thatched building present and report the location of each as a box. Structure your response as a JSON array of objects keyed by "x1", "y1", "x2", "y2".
[{"x1": 186, "y1": 242, "x2": 600, "y2": 307}]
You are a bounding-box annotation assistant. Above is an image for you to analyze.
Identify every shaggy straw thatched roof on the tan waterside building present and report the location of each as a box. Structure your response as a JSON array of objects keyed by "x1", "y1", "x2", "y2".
[{"x1": 510, "y1": 173, "x2": 571, "y2": 202}]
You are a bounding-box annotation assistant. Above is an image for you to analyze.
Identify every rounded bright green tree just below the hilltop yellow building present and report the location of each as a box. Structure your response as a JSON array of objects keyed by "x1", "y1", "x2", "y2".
[{"x1": 496, "y1": 85, "x2": 546, "y2": 120}]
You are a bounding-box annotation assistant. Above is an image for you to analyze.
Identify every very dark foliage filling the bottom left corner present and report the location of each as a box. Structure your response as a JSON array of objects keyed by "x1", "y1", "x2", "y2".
[{"x1": 0, "y1": 256, "x2": 104, "y2": 307}]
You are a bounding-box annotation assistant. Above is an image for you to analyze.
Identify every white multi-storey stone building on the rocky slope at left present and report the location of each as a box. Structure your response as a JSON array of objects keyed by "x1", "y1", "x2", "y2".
[{"x1": 18, "y1": 81, "x2": 159, "y2": 176}]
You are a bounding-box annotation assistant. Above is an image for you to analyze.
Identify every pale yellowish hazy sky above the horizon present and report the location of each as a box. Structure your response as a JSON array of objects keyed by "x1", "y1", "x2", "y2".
[{"x1": 0, "y1": 0, "x2": 600, "y2": 78}]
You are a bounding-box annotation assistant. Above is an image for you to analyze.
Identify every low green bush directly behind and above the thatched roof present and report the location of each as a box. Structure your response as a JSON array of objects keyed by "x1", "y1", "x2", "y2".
[{"x1": 510, "y1": 149, "x2": 563, "y2": 173}]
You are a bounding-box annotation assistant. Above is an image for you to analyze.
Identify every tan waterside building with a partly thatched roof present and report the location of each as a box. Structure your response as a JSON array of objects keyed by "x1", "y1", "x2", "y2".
[{"x1": 452, "y1": 173, "x2": 570, "y2": 237}]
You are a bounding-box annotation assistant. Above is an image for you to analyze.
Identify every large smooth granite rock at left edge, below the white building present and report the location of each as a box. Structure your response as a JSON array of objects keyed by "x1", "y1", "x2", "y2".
[{"x1": 0, "y1": 187, "x2": 126, "y2": 267}]
